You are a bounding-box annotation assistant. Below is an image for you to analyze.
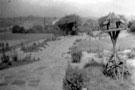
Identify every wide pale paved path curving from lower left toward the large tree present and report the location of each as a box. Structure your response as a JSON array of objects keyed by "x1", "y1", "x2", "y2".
[{"x1": 0, "y1": 36, "x2": 85, "y2": 90}]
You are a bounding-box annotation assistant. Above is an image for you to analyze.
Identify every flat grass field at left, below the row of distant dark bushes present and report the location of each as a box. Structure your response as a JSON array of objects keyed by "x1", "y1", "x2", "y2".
[{"x1": 0, "y1": 33, "x2": 56, "y2": 53}]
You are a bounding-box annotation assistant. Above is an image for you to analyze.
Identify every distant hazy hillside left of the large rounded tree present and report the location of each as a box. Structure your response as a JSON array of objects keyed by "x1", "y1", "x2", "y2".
[{"x1": 0, "y1": 16, "x2": 57, "y2": 28}]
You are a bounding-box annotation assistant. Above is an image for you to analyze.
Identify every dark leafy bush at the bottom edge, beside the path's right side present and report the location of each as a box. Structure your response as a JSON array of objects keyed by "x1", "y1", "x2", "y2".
[{"x1": 63, "y1": 67, "x2": 83, "y2": 90}]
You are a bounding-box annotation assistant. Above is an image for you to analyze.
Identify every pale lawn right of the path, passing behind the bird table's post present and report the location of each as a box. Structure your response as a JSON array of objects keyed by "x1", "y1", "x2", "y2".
[{"x1": 73, "y1": 32, "x2": 135, "y2": 52}]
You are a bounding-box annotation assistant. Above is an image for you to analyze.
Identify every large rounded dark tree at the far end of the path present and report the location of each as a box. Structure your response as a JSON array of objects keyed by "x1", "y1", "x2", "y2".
[{"x1": 56, "y1": 14, "x2": 81, "y2": 35}]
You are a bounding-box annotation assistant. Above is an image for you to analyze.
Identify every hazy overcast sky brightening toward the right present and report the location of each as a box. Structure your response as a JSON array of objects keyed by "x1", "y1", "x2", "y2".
[{"x1": 0, "y1": 0, "x2": 135, "y2": 17}]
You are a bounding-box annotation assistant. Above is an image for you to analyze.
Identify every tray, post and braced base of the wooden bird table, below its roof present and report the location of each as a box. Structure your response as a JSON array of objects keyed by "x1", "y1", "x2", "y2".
[{"x1": 104, "y1": 28, "x2": 128, "y2": 80}]
